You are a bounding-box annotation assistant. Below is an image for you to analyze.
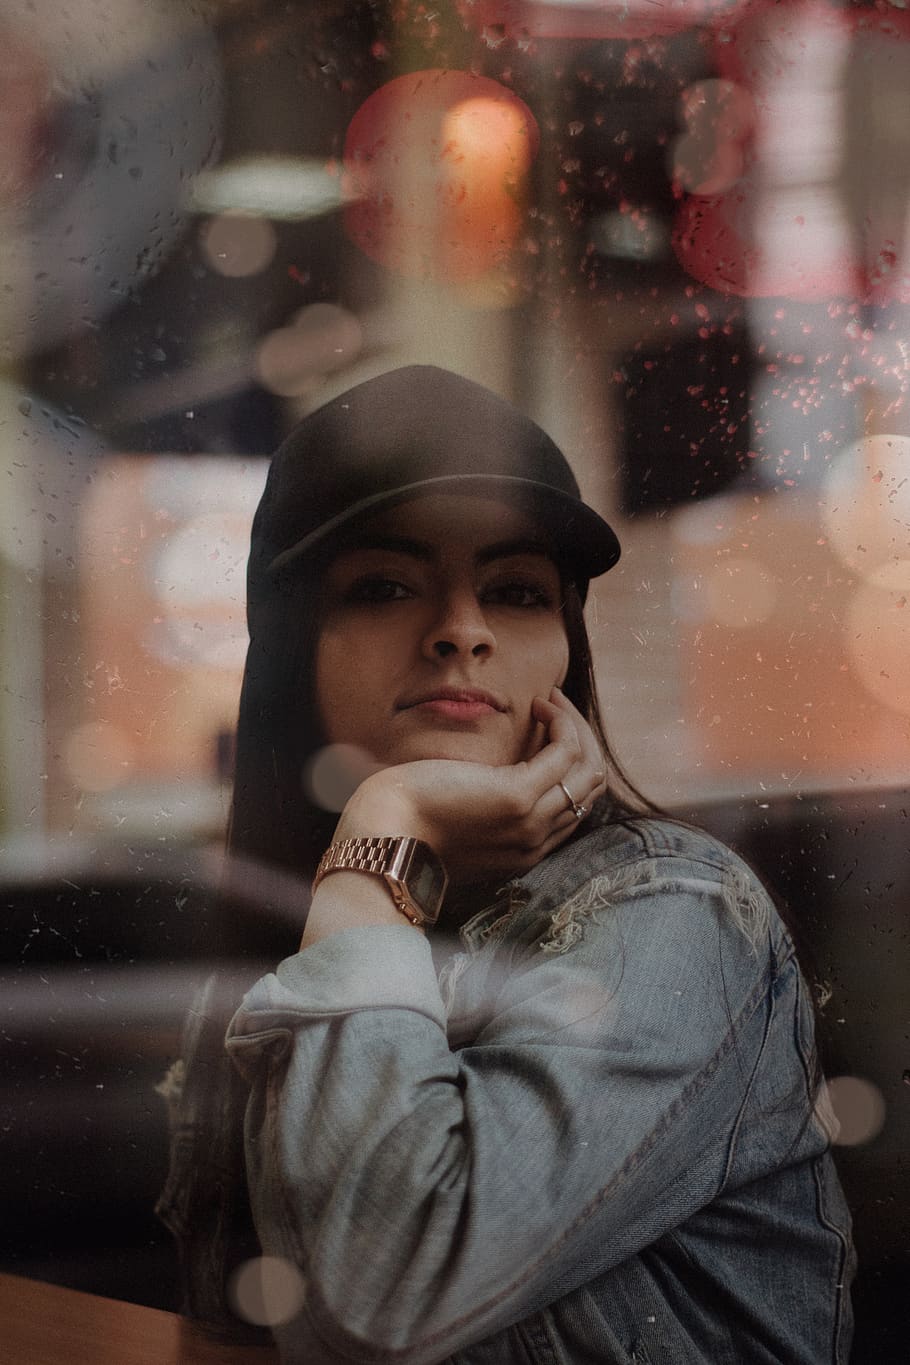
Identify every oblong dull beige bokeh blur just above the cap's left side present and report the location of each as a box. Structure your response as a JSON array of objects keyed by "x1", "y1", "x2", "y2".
[{"x1": 255, "y1": 303, "x2": 363, "y2": 399}]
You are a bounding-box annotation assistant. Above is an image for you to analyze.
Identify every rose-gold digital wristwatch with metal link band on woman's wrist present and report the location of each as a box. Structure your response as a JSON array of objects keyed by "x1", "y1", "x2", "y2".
[{"x1": 312, "y1": 834, "x2": 449, "y2": 924}]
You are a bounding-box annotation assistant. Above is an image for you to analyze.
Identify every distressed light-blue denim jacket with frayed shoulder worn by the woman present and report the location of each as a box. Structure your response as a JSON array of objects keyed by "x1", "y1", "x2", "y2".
[{"x1": 158, "y1": 819, "x2": 854, "y2": 1365}]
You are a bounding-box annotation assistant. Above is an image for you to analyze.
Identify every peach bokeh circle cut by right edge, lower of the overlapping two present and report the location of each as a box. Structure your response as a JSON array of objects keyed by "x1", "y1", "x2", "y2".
[{"x1": 843, "y1": 558, "x2": 910, "y2": 715}]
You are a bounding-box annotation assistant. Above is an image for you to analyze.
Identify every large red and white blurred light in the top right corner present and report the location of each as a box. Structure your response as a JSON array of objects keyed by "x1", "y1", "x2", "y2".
[{"x1": 674, "y1": 0, "x2": 910, "y2": 303}]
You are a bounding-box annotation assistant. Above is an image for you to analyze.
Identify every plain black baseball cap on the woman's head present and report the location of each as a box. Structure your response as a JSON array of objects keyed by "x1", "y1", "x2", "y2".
[{"x1": 250, "y1": 364, "x2": 619, "y2": 616}]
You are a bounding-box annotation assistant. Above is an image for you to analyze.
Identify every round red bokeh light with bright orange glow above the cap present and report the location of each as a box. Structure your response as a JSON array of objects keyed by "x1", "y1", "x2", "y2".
[{"x1": 344, "y1": 70, "x2": 539, "y2": 281}]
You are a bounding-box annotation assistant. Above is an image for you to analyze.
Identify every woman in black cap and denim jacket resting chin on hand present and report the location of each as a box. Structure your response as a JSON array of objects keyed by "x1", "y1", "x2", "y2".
[{"x1": 158, "y1": 367, "x2": 853, "y2": 1365}]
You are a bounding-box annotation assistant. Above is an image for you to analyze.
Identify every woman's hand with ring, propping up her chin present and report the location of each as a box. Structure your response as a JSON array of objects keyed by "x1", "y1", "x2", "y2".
[{"x1": 334, "y1": 688, "x2": 606, "y2": 882}]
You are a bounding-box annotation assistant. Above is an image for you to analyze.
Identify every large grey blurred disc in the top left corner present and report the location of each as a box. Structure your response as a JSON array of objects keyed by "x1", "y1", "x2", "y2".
[{"x1": 0, "y1": 0, "x2": 222, "y2": 363}]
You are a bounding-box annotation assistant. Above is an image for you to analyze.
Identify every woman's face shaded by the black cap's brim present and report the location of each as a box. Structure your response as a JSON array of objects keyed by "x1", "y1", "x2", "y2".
[{"x1": 317, "y1": 494, "x2": 569, "y2": 766}]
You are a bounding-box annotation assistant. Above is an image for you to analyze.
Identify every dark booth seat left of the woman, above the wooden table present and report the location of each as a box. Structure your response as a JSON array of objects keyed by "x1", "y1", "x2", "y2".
[{"x1": 0, "y1": 844, "x2": 303, "y2": 1309}]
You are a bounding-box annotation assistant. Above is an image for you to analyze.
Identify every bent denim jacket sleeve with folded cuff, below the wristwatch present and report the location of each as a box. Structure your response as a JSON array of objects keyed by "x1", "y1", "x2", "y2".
[{"x1": 228, "y1": 875, "x2": 772, "y2": 1365}]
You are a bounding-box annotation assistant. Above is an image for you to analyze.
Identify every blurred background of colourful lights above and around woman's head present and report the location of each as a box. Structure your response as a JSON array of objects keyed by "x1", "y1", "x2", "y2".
[{"x1": 0, "y1": 0, "x2": 910, "y2": 1360}]
